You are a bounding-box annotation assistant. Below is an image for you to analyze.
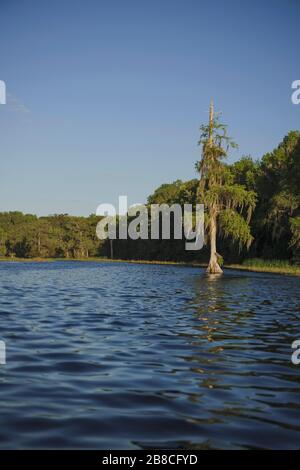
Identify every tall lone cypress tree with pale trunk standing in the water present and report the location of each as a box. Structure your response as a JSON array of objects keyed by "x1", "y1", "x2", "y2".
[{"x1": 196, "y1": 101, "x2": 256, "y2": 274}]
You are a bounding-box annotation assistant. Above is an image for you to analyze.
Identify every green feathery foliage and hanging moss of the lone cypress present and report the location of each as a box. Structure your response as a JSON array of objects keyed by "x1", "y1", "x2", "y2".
[{"x1": 196, "y1": 110, "x2": 257, "y2": 258}]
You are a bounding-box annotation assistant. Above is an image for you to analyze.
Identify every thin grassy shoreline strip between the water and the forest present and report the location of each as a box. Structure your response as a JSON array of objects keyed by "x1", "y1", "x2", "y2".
[{"x1": 0, "y1": 257, "x2": 300, "y2": 276}]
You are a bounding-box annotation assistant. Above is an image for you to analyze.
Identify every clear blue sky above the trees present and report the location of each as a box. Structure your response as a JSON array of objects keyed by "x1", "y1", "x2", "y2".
[{"x1": 0, "y1": 0, "x2": 300, "y2": 215}]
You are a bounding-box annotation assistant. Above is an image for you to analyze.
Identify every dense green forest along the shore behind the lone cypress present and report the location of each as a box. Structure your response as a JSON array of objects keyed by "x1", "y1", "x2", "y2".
[{"x1": 0, "y1": 131, "x2": 300, "y2": 262}]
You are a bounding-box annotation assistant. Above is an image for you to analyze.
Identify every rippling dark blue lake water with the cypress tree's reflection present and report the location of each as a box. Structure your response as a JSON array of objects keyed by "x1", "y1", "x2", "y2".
[{"x1": 0, "y1": 262, "x2": 300, "y2": 449}]
